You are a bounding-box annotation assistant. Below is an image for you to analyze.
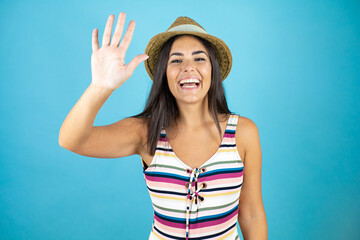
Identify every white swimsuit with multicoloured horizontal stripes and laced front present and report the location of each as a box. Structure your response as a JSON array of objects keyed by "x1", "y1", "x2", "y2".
[{"x1": 143, "y1": 114, "x2": 244, "y2": 240}]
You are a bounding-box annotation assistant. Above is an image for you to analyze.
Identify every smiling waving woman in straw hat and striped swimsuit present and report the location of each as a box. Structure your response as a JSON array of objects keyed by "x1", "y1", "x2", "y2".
[{"x1": 59, "y1": 13, "x2": 267, "y2": 240}]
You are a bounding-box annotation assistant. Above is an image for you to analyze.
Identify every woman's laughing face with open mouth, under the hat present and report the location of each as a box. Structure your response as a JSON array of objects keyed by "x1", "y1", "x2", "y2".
[{"x1": 166, "y1": 36, "x2": 211, "y2": 103}]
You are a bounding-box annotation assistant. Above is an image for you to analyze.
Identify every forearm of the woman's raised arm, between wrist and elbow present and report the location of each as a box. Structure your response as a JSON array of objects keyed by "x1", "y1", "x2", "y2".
[{"x1": 59, "y1": 84, "x2": 113, "y2": 149}]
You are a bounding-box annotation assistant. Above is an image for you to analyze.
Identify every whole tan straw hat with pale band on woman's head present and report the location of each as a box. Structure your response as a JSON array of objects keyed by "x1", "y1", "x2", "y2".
[{"x1": 144, "y1": 17, "x2": 232, "y2": 81}]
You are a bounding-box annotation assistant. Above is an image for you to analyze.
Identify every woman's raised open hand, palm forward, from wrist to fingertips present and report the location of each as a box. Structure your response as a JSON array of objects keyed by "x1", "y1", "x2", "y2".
[{"x1": 91, "y1": 13, "x2": 148, "y2": 90}]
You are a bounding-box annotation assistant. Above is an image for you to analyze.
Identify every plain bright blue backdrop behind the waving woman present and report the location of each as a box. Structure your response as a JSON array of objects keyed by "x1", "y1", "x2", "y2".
[{"x1": 0, "y1": 0, "x2": 360, "y2": 240}]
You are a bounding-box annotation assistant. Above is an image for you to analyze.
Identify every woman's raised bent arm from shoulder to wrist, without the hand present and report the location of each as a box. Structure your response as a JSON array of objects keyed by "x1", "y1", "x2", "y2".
[{"x1": 59, "y1": 84, "x2": 146, "y2": 158}]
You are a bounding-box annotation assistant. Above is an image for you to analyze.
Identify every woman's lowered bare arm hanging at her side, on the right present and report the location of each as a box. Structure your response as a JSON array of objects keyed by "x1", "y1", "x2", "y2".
[{"x1": 236, "y1": 117, "x2": 268, "y2": 240}]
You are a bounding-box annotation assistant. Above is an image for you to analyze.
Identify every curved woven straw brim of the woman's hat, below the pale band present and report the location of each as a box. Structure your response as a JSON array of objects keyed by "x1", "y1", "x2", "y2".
[{"x1": 144, "y1": 31, "x2": 232, "y2": 81}]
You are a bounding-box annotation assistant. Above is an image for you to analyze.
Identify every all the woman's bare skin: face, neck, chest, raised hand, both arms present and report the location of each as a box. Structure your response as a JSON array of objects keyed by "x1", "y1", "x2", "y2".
[{"x1": 59, "y1": 13, "x2": 267, "y2": 240}]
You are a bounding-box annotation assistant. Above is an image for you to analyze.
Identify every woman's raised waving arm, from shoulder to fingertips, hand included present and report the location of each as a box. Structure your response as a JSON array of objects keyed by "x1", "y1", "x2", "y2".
[{"x1": 59, "y1": 13, "x2": 147, "y2": 158}]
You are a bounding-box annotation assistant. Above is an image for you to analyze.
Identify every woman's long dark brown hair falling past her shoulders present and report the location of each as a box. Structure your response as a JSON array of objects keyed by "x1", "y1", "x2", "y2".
[{"x1": 132, "y1": 35, "x2": 231, "y2": 155}]
